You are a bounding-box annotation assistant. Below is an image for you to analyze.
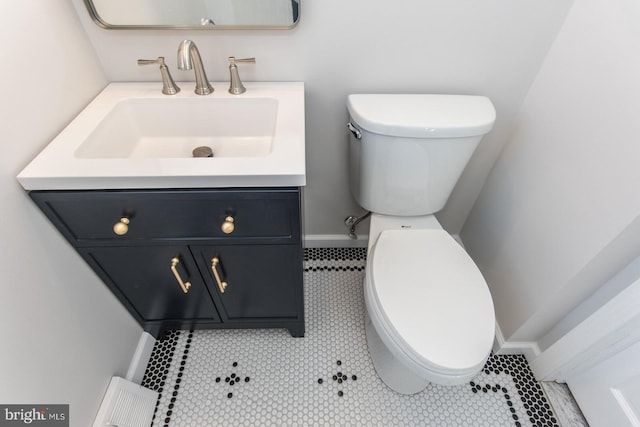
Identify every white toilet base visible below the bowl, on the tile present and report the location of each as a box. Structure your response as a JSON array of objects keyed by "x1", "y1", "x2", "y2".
[{"x1": 364, "y1": 309, "x2": 429, "y2": 394}]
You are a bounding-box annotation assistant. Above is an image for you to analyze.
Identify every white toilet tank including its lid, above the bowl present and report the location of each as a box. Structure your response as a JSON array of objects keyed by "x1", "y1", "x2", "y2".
[{"x1": 347, "y1": 94, "x2": 496, "y2": 216}]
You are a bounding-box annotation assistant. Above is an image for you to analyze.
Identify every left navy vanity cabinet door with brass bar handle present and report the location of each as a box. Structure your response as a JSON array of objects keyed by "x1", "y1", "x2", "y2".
[{"x1": 80, "y1": 246, "x2": 220, "y2": 321}]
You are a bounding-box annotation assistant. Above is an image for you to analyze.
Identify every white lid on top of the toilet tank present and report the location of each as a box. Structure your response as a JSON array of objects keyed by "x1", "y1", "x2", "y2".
[{"x1": 347, "y1": 94, "x2": 496, "y2": 138}]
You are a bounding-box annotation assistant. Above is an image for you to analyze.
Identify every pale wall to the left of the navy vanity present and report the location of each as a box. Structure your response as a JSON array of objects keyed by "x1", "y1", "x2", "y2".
[{"x1": 0, "y1": 0, "x2": 141, "y2": 427}]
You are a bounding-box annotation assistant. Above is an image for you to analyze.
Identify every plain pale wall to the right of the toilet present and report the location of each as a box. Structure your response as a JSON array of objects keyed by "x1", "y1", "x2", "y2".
[{"x1": 461, "y1": 0, "x2": 640, "y2": 344}]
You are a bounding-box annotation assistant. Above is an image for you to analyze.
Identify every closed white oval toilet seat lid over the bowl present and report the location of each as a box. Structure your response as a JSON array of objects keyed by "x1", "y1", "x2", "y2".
[{"x1": 369, "y1": 229, "x2": 495, "y2": 373}]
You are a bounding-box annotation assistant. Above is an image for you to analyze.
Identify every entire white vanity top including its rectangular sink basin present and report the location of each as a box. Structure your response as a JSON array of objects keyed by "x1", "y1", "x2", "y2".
[{"x1": 18, "y1": 82, "x2": 305, "y2": 190}]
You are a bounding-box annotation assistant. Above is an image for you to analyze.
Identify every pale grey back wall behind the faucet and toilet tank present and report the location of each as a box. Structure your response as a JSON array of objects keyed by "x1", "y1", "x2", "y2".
[{"x1": 73, "y1": 0, "x2": 572, "y2": 236}]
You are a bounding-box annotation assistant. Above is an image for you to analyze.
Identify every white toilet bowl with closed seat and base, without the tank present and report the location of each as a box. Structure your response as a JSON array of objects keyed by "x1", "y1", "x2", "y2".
[{"x1": 364, "y1": 215, "x2": 495, "y2": 394}]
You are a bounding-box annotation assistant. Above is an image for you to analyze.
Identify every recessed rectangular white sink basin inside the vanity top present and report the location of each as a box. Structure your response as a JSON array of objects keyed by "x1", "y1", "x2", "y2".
[{"x1": 75, "y1": 97, "x2": 278, "y2": 159}]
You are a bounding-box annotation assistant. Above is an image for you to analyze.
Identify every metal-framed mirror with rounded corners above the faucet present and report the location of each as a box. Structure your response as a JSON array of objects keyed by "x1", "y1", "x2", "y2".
[{"x1": 84, "y1": 0, "x2": 300, "y2": 30}]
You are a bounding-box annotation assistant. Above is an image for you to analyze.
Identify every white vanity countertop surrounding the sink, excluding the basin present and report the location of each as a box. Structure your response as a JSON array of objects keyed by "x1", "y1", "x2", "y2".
[{"x1": 17, "y1": 82, "x2": 306, "y2": 190}]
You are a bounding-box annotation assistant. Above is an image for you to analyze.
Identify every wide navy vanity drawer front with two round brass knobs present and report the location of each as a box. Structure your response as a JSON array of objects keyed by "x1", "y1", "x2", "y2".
[{"x1": 30, "y1": 188, "x2": 300, "y2": 246}]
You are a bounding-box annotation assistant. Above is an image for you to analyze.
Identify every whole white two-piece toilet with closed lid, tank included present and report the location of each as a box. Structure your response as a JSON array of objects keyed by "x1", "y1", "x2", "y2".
[{"x1": 347, "y1": 94, "x2": 495, "y2": 394}]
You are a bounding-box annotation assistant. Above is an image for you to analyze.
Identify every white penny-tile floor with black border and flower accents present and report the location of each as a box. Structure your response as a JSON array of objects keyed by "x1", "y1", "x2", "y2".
[{"x1": 142, "y1": 248, "x2": 559, "y2": 427}]
